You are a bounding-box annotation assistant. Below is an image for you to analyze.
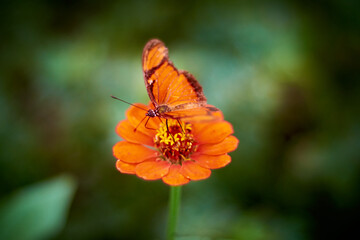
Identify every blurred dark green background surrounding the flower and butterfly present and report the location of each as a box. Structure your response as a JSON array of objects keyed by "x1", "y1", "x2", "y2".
[{"x1": 0, "y1": 0, "x2": 360, "y2": 240}]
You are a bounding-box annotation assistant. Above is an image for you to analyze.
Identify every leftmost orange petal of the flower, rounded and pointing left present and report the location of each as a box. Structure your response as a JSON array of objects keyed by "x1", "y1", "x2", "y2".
[{"x1": 113, "y1": 141, "x2": 158, "y2": 163}]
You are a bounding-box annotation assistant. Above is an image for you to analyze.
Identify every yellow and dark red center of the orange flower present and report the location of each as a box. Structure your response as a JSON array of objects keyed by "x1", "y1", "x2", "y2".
[{"x1": 154, "y1": 120, "x2": 197, "y2": 164}]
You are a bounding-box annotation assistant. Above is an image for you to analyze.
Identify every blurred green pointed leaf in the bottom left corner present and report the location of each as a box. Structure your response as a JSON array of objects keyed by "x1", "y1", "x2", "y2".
[{"x1": 0, "y1": 175, "x2": 76, "y2": 240}]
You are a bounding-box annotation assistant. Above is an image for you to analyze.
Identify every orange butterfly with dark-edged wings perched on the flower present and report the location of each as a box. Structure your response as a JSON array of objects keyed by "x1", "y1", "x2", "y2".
[{"x1": 142, "y1": 39, "x2": 219, "y2": 124}]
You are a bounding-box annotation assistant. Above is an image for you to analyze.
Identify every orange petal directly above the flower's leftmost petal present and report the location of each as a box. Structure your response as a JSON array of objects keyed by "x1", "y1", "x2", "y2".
[{"x1": 116, "y1": 120, "x2": 154, "y2": 146}]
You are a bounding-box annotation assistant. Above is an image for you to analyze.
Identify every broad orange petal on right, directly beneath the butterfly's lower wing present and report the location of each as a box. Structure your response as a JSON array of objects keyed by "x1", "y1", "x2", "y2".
[{"x1": 192, "y1": 121, "x2": 234, "y2": 144}]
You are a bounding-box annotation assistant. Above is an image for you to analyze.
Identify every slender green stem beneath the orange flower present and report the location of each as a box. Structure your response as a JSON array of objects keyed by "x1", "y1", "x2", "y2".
[{"x1": 166, "y1": 186, "x2": 181, "y2": 240}]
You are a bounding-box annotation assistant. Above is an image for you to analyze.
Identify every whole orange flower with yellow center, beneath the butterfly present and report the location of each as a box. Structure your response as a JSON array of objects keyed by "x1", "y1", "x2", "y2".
[{"x1": 113, "y1": 104, "x2": 239, "y2": 186}]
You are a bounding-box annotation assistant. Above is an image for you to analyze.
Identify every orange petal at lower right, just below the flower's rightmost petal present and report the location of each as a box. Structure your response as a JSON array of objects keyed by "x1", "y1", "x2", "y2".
[{"x1": 191, "y1": 154, "x2": 231, "y2": 169}]
